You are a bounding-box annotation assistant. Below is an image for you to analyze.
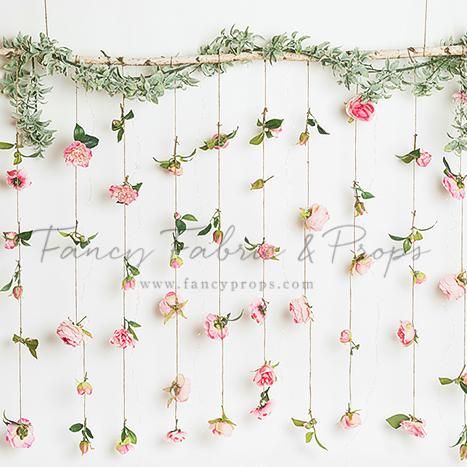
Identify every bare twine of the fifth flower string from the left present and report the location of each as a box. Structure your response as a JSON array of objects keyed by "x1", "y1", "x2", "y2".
[{"x1": 217, "y1": 54, "x2": 225, "y2": 413}]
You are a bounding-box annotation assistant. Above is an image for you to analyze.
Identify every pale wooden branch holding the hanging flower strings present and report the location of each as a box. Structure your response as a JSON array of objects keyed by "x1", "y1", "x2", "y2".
[{"x1": 0, "y1": 45, "x2": 467, "y2": 67}]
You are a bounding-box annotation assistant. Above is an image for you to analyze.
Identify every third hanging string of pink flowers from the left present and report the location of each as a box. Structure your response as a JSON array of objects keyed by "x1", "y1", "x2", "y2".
[{"x1": 109, "y1": 83, "x2": 142, "y2": 454}]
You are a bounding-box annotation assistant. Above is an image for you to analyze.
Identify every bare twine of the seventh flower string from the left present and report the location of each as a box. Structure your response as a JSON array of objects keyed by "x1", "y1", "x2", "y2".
[{"x1": 303, "y1": 61, "x2": 313, "y2": 417}]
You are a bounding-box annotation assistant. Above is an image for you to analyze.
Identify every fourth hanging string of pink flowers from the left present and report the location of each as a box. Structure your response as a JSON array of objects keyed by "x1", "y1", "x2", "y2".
[{"x1": 156, "y1": 89, "x2": 196, "y2": 444}]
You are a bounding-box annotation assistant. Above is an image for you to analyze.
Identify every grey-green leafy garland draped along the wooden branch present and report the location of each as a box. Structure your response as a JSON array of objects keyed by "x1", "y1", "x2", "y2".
[{"x1": 0, "y1": 27, "x2": 467, "y2": 157}]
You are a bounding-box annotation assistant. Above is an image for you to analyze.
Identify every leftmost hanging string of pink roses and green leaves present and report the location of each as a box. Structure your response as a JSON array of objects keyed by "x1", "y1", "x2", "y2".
[{"x1": 1, "y1": 61, "x2": 39, "y2": 448}]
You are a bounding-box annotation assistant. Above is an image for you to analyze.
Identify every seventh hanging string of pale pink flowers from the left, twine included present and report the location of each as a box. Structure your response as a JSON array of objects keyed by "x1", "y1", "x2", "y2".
[{"x1": 289, "y1": 62, "x2": 329, "y2": 449}]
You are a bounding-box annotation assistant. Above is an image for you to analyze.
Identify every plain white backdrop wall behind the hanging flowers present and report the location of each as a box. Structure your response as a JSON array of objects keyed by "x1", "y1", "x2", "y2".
[{"x1": 0, "y1": 0, "x2": 467, "y2": 467}]
